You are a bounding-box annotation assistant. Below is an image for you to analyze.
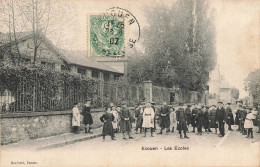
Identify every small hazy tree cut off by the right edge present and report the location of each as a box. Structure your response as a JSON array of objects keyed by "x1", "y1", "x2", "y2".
[{"x1": 244, "y1": 69, "x2": 260, "y2": 104}]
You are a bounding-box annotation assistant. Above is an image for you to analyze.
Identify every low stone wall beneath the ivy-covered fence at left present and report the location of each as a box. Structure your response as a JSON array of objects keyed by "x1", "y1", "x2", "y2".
[{"x1": 1, "y1": 108, "x2": 136, "y2": 145}]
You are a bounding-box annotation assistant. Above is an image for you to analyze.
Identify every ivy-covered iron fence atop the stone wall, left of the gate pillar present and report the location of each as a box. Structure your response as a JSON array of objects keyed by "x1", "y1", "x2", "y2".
[{"x1": 0, "y1": 65, "x2": 144, "y2": 113}]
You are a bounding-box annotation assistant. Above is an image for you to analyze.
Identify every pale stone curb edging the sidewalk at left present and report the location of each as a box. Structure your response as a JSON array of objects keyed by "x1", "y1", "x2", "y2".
[{"x1": 36, "y1": 134, "x2": 102, "y2": 151}]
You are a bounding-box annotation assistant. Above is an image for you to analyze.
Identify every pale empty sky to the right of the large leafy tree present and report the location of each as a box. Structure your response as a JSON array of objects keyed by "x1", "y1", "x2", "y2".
[{"x1": 212, "y1": 0, "x2": 260, "y2": 98}]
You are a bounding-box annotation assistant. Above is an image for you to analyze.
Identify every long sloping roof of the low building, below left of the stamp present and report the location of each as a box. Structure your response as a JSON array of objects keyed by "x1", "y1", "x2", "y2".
[{"x1": 60, "y1": 49, "x2": 122, "y2": 74}]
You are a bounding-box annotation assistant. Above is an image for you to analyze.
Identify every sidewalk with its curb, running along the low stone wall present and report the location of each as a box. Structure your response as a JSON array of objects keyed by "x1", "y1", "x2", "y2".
[{"x1": 1, "y1": 128, "x2": 102, "y2": 151}]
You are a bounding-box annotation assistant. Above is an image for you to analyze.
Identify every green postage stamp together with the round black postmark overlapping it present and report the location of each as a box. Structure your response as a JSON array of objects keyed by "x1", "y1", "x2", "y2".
[{"x1": 89, "y1": 7, "x2": 140, "y2": 57}]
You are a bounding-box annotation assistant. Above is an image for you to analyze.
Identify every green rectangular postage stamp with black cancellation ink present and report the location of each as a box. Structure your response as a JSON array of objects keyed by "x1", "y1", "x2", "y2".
[{"x1": 88, "y1": 14, "x2": 125, "y2": 57}]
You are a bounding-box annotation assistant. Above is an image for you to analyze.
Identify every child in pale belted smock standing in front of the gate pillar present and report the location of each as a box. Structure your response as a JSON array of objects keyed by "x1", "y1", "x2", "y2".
[{"x1": 142, "y1": 102, "x2": 154, "y2": 137}]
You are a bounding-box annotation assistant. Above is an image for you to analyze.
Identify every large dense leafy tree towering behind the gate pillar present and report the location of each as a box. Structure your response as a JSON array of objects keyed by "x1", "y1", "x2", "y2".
[{"x1": 128, "y1": 0, "x2": 215, "y2": 92}]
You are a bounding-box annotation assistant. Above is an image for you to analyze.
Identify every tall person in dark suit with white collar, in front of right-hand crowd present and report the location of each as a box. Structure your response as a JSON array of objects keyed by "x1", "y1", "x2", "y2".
[{"x1": 217, "y1": 102, "x2": 226, "y2": 137}]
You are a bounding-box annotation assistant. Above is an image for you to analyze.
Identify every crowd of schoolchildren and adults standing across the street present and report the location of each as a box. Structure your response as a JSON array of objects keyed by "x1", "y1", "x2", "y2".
[{"x1": 72, "y1": 101, "x2": 260, "y2": 141}]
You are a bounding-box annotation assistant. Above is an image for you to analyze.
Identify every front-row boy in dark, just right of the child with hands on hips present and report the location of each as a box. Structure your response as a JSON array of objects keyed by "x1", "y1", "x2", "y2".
[{"x1": 121, "y1": 101, "x2": 133, "y2": 140}]
